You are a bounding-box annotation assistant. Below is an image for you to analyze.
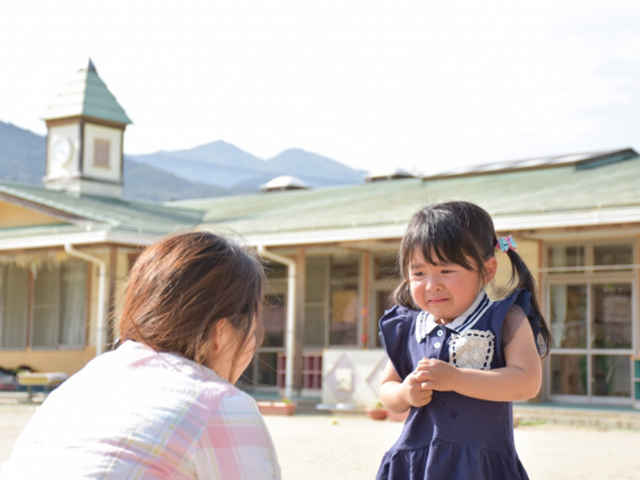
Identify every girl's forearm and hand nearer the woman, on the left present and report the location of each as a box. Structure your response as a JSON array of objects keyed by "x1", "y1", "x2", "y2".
[{"x1": 380, "y1": 362, "x2": 433, "y2": 413}]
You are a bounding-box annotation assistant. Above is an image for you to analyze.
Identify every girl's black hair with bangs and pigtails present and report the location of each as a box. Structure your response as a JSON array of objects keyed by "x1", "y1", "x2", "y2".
[{"x1": 394, "y1": 201, "x2": 551, "y2": 352}]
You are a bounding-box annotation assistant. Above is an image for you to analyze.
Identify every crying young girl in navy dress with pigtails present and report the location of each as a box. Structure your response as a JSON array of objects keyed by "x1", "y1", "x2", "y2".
[{"x1": 377, "y1": 202, "x2": 549, "y2": 480}]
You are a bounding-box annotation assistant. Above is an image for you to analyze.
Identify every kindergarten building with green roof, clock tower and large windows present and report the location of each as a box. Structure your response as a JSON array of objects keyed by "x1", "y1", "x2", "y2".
[{"x1": 0, "y1": 64, "x2": 640, "y2": 407}]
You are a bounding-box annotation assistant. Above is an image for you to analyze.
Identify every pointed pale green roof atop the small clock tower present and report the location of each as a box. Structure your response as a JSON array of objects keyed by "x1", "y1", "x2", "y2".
[{"x1": 44, "y1": 59, "x2": 132, "y2": 125}]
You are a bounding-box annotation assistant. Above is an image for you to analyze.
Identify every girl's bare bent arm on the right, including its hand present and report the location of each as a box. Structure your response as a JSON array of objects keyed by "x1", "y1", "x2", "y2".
[{"x1": 417, "y1": 306, "x2": 542, "y2": 402}]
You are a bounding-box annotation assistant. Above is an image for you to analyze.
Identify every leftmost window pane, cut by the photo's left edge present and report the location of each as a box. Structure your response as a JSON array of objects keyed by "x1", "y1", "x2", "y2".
[{"x1": 0, "y1": 265, "x2": 28, "y2": 348}]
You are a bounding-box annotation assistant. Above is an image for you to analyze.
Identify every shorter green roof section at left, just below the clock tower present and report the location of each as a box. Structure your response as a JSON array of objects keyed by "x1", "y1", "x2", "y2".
[{"x1": 0, "y1": 183, "x2": 202, "y2": 235}]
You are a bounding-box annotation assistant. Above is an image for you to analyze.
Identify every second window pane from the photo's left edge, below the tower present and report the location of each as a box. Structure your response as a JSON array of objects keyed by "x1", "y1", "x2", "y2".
[{"x1": 31, "y1": 265, "x2": 60, "y2": 347}]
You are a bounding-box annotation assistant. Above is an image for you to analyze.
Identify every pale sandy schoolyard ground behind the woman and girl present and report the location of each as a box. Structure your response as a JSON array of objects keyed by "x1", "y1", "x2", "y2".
[{"x1": 0, "y1": 402, "x2": 640, "y2": 480}]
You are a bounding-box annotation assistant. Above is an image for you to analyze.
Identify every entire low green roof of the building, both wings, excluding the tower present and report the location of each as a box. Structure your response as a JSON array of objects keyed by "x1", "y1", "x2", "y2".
[{"x1": 0, "y1": 152, "x2": 640, "y2": 245}]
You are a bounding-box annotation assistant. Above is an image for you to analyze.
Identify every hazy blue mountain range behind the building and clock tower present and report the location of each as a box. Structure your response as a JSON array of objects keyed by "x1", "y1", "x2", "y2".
[{"x1": 0, "y1": 121, "x2": 365, "y2": 202}]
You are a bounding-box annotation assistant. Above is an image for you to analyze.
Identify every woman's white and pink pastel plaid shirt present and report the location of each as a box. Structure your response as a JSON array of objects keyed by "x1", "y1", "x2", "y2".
[{"x1": 3, "y1": 341, "x2": 280, "y2": 480}]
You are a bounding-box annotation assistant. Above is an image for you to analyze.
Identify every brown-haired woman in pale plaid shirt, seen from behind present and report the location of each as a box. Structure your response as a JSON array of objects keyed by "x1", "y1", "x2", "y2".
[{"x1": 5, "y1": 232, "x2": 280, "y2": 479}]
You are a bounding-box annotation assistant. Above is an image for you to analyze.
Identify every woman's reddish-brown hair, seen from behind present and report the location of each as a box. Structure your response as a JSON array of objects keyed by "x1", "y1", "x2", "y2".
[{"x1": 119, "y1": 232, "x2": 265, "y2": 365}]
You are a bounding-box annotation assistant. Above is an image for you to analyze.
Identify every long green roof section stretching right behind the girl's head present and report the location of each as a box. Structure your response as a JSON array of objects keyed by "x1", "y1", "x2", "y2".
[{"x1": 171, "y1": 152, "x2": 640, "y2": 236}]
